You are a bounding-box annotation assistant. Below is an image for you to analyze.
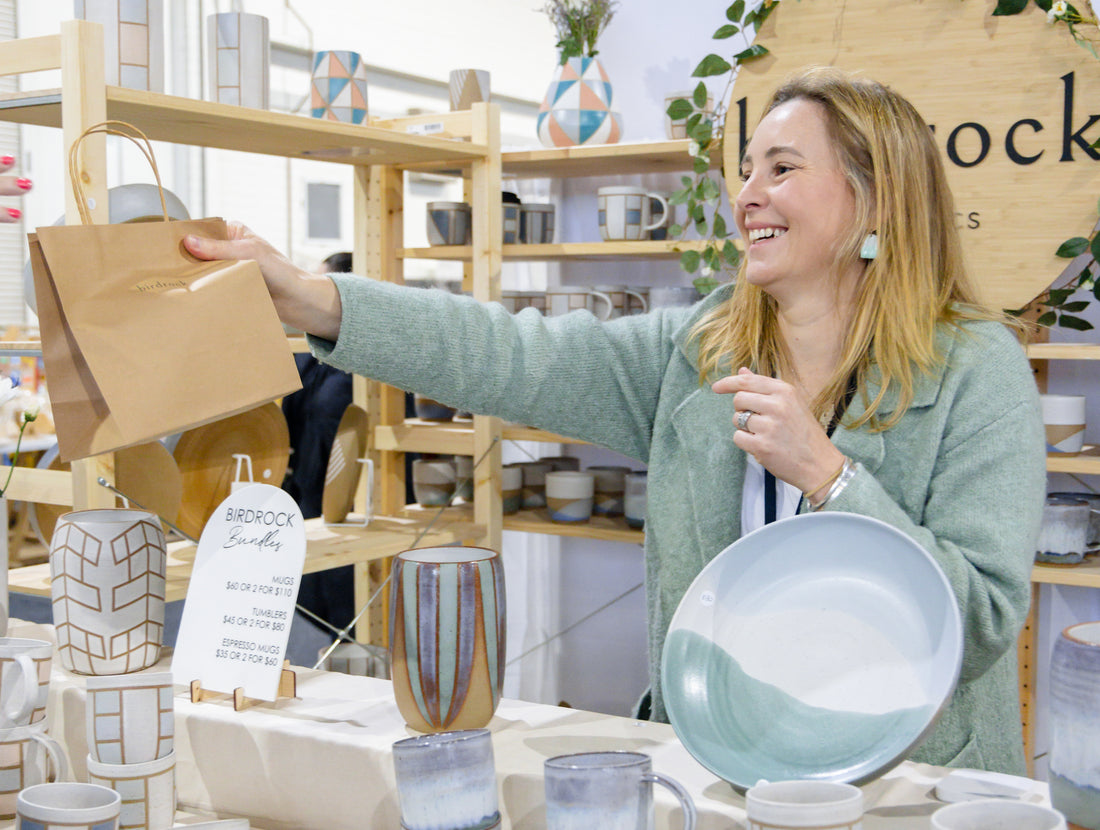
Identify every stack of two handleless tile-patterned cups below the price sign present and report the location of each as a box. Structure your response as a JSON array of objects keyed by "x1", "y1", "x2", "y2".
[{"x1": 85, "y1": 672, "x2": 176, "y2": 830}]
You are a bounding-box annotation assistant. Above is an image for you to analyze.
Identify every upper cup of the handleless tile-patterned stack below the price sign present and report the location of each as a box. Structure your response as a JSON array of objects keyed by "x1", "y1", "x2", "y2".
[{"x1": 85, "y1": 672, "x2": 176, "y2": 764}]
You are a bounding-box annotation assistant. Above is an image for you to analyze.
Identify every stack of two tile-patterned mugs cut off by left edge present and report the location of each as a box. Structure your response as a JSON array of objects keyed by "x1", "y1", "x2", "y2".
[{"x1": 0, "y1": 637, "x2": 68, "y2": 819}]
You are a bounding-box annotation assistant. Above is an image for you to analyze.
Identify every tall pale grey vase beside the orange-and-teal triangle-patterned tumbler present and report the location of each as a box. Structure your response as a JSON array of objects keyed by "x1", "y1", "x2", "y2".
[{"x1": 207, "y1": 12, "x2": 271, "y2": 110}]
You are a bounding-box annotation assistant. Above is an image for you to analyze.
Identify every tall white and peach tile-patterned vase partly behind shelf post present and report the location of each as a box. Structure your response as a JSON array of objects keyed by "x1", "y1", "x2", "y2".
[{"x1": 73, "y1": 0, "x2": 165, "y2": 92}]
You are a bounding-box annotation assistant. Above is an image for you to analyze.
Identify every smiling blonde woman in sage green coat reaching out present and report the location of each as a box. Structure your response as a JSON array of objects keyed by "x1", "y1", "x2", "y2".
[{"x1": 188, "y1": 69, "x2": 1045, "y2": 773}]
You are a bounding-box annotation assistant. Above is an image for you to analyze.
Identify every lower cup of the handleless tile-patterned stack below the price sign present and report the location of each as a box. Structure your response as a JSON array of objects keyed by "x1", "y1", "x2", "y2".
[{"x1": 88, "y1": 752, "x2": 176, "y2": 830}]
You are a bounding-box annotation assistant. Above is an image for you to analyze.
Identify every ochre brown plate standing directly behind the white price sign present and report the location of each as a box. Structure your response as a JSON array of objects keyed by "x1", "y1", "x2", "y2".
[{"x1": 173, "y1": 403, "x2": 290, "y2": 539}]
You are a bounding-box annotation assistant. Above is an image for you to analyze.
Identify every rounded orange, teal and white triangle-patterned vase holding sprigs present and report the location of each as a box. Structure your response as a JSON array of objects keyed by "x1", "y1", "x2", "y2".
[{"x1": 537, "y1": 57, "x2": 623, "y2": 147}]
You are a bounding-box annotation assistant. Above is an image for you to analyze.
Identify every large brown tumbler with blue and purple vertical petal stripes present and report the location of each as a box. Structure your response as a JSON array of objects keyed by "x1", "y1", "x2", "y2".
[{"x1": 389, "y1": 547, "x2": 505, "y2": 732}]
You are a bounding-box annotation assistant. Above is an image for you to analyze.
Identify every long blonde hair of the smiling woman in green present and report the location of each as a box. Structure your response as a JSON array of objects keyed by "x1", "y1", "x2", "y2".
[{"x1": 692, "y1": 67, "x2": 1005, "y2": 430}]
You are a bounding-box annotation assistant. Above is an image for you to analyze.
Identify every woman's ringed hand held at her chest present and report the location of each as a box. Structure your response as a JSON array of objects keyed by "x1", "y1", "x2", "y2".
[{"x1": 711, "y1": 367, "x2": 844, "y2": 503}]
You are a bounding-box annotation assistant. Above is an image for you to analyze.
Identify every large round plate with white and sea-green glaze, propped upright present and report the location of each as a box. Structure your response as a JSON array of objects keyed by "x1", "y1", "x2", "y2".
[{"x1": 661, "y1": 512, "x2": 963, "y2": 790}]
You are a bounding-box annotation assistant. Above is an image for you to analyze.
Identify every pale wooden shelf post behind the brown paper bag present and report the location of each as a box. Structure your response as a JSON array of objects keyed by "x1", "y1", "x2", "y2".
[{"x1": 61, "y1": 20, "x2": 114, "y2": 510}]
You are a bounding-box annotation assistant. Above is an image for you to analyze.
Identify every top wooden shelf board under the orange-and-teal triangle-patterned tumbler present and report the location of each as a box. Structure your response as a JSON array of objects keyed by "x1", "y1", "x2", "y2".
[{"x1": 0, "y1": 86, "x2": 486, "y2": 165}]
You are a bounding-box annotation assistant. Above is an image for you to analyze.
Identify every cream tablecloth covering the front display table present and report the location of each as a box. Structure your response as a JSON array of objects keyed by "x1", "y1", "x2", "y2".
[{"x1": 8, "y1": 621, "x2": 1048, "y2": 830}]
